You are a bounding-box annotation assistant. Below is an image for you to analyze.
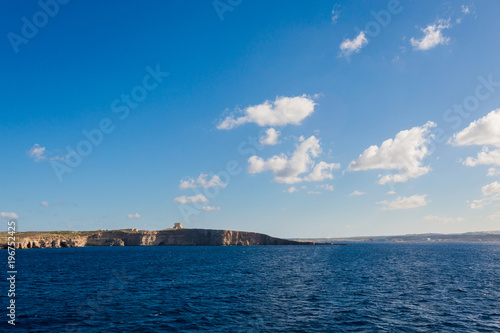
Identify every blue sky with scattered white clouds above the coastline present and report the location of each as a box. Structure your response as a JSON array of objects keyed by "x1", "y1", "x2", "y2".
[{"x1": 0, "y1": 0, "x2": 500, "y2": 237}]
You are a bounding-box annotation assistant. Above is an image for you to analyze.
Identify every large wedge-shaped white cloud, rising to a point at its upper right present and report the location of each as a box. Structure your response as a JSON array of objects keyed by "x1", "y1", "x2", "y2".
[{"x1": 348, "y1": 121, "x2": 436, "y2": 185}]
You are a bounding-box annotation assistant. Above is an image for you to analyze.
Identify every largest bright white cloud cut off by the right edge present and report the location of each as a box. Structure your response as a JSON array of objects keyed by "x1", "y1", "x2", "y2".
[{"x1": 450, "y1": 109, "x2": 500, "y2": 169}]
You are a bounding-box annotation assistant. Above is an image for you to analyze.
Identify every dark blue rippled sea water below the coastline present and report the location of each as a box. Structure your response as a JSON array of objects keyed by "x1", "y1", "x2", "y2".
[{"x1": 0, "y1": 243, "x2": 500, "y2": 332}]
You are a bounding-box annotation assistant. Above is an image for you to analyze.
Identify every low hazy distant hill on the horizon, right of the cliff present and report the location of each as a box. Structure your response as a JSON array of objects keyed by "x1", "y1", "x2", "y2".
[{"x1": 292, "y1": 230, "x2": 500, "y2": 242}]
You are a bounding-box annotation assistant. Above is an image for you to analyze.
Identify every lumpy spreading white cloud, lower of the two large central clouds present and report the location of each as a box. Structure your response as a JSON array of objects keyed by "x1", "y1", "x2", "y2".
[{"x1": 248, "y1": 136, "x2": 340, "y2": 184}]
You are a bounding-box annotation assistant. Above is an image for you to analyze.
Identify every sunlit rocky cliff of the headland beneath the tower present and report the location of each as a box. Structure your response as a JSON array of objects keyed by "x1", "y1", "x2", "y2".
[{"x1": 0, "y1": 229, "x2": 314, "y2": 249}]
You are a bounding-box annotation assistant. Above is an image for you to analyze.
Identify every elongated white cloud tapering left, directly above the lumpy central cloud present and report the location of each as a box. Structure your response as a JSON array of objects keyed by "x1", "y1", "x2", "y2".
[{"x1": 217, "y1": 95, "x2": 316, "y2": 130}]
